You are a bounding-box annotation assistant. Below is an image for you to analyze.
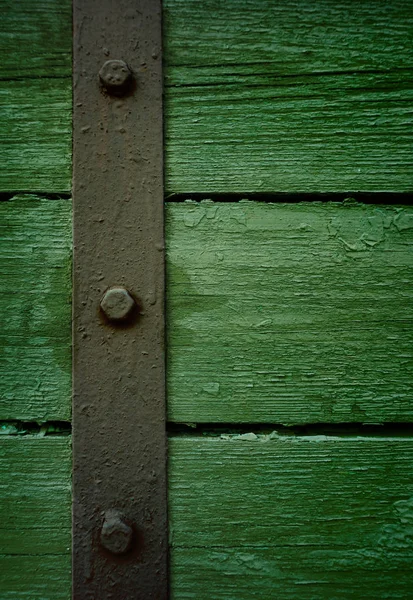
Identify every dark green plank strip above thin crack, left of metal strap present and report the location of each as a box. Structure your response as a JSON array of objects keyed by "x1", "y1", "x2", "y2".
[{"x1": 0, "y1": 0, "x2": 72, "y2": 79}]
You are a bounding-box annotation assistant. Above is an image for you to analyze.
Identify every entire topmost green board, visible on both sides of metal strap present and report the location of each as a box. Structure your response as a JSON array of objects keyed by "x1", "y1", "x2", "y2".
[{"x1": 0, "y1": 0, "x2": 413, "y2": 193}]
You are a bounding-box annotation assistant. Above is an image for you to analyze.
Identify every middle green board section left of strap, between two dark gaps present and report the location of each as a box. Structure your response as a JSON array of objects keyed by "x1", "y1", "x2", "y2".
[{"x1": 0, "y1": 195, "x2": 72, "y2": 421}]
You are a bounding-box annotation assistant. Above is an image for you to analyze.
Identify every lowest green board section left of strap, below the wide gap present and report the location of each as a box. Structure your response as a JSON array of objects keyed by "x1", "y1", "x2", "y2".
[{"x1": 0, "y1": 436, "x2": 71, "y2": 600}]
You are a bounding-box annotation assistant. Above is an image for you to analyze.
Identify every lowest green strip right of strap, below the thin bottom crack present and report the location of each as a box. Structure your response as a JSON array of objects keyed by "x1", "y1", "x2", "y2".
[{"x1": 171, "y1": 547, "x2": 412, "y2": 600}]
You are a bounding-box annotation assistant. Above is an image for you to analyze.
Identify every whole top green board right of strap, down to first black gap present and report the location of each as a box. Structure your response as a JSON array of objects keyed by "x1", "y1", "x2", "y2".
[{"x1": 164, "y1": 0, "x2": 413, "y2": 193}]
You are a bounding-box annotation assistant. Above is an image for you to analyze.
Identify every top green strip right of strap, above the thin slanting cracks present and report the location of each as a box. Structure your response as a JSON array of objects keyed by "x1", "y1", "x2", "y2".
[{"x1": 163, "y1": 0, "x2": 413, "y2": 77}]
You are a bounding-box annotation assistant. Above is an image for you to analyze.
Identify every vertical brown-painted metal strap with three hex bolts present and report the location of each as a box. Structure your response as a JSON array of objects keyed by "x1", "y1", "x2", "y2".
[{"x1": 73, "y1": 0, "x2": 167, "y2": 600}]
